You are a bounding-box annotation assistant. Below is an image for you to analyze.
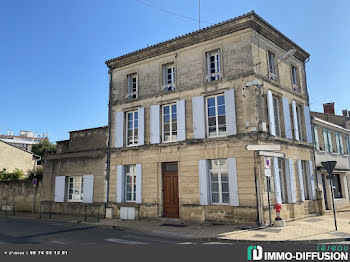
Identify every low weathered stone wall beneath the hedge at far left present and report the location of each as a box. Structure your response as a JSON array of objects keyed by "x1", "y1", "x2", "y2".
[{"x1": 0, "y1": 180, "x2": 41, "y2": 212}]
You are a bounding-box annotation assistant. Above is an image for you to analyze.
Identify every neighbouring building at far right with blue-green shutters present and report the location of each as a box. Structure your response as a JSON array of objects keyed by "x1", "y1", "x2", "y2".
[{"x1": 311, "y1": 104, "x2": 350, "y2": 210}]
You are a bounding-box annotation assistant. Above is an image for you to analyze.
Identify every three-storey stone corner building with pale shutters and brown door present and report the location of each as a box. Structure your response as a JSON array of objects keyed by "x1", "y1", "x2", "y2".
[{"x1": 95, "y1": 9, "x2": 319, "y2": 224}]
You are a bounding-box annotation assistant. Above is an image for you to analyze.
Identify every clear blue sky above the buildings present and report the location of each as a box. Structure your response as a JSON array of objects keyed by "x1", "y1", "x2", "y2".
[{"x1": 0, "y1": 0, "x2": 350, "y2": 142}]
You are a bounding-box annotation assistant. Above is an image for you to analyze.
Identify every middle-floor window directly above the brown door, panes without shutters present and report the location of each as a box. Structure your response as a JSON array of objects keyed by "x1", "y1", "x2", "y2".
[{"x1": 163, "y1": 104, "x2": 177, "y2": 142}]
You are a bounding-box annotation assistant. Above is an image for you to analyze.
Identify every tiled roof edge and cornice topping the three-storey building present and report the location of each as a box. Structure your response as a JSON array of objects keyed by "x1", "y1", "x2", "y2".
[{"x1": 105, "y1": 10, "x2": 310, "y2": 69}]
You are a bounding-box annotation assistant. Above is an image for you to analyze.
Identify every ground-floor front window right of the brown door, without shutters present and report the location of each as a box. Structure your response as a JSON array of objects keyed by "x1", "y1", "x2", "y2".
[{"x1": 209, "y1": 159, "x2": 230, "y2": 204}]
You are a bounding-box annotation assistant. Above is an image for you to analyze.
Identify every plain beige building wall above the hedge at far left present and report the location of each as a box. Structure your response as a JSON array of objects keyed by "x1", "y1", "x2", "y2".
[{"x1": 0, "y1": 140, "x2": 40, "y2": 173}]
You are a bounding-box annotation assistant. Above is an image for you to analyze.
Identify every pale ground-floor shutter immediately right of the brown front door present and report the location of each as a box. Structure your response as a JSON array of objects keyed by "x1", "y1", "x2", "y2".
[{"x1": 198, "y1": 159, "x2": 210, "y2": 206}]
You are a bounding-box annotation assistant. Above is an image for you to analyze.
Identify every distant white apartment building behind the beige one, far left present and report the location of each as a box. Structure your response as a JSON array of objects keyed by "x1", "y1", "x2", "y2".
[{"x1": 0, "y1": 130, "x2": 49, "y2": 151}]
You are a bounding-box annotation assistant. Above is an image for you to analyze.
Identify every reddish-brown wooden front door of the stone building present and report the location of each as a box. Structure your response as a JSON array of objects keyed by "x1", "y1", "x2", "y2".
[{"x1": 163, "y1": 162, "x2": 179, "y2": 218}]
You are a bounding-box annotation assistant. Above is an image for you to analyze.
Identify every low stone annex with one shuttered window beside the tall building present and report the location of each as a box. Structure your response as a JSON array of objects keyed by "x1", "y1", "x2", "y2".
[{"x1": 41, "y1": 126, "x2": 107, "y2": 213}]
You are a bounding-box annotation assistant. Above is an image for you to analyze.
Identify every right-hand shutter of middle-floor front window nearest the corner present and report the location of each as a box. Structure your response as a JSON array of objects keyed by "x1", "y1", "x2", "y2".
[{"x1": 225, "y1": 89, "x2": 237, "y2": 136}]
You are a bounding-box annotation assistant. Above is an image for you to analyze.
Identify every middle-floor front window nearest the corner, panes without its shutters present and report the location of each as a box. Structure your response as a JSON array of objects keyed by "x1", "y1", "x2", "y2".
[{"x1": 207, "y1": 95, "x2": 226, "y2": 137}]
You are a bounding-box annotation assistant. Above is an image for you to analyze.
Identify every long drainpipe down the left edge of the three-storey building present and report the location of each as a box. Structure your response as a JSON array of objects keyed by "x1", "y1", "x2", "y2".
[{"x1": 105, "y1": 68, "x2": 113, "y2": 217}]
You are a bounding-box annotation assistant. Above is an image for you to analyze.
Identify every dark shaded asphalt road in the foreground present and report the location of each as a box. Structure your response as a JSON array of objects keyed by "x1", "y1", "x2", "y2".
[{"x1": 0, "y1": 217, "x2": 231, "y2": 246}]
